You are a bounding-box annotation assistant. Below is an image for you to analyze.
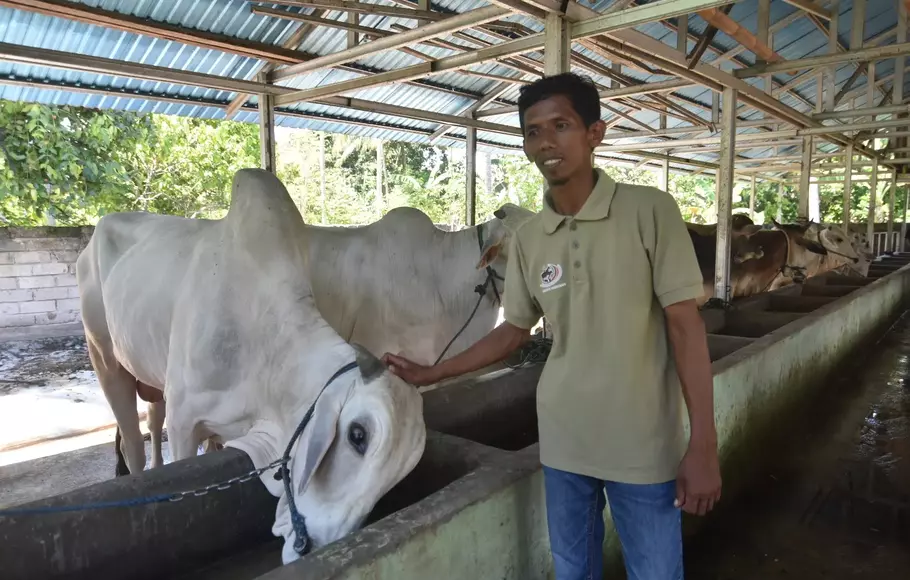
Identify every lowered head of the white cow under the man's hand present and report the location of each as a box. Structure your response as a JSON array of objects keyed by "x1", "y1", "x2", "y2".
[{"x1": 268, "y1": 345, "x2": 426, "y2": 564}]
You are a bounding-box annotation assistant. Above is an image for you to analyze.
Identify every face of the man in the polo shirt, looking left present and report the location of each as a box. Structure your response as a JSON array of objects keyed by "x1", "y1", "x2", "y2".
[{"x1": 524, "y1": 95, "x2": 606, "y2": 187}]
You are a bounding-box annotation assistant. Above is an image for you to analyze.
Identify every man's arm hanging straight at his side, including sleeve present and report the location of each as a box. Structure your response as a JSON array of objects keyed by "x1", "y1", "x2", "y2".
[{"x1": 649, "y1": 194, "x2": 721, "y2": 515}]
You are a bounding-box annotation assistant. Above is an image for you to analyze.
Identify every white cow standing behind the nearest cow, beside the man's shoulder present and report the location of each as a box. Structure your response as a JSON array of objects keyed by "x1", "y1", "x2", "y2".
[{"x1": 303, "y1": 204, "x2": 534, "y2": 364}]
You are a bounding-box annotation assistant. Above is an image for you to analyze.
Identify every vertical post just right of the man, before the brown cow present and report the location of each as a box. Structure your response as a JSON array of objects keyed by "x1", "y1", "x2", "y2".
[{"x1": 714, "y1": 87, "x2": 736, "y2": 303}]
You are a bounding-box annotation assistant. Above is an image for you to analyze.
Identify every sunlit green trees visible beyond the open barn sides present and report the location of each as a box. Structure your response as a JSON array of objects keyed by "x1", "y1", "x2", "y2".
[{"x1": 0, "y1": 101, "x2": 904, "y2": 227}]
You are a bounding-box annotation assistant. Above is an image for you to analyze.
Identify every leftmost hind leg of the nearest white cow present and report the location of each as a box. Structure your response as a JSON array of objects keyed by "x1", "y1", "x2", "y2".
[{"x1": 88, "y1": 340, "x2": 145, "y2": 473}]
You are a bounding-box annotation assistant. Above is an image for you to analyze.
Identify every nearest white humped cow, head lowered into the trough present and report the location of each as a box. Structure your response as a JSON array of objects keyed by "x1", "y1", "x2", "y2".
[{"x1": 76, "y1": 169, "x2": 426, "y2": 563}]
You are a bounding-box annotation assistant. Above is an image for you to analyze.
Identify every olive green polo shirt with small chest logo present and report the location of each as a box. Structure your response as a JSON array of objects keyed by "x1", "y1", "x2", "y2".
[{"x1": 503, "y1": 169, "x2": 702, "y2": 483}]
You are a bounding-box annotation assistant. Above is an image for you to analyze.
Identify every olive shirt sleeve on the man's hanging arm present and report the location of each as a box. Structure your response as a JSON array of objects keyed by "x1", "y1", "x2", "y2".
[{"x1": 643, "y1": 191, "x2": 704, "y2": 308}]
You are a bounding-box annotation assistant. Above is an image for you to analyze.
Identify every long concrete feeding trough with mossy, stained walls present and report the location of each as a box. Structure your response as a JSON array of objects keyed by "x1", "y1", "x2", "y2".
[{"x1": 0, "y1": 256, "x2": 910, "y2": 580}]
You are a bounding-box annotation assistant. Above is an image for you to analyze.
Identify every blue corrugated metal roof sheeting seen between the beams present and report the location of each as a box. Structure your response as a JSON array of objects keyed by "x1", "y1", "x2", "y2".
[{"x1": 0, "y1": 0, "x2": 910, "y2": 170}]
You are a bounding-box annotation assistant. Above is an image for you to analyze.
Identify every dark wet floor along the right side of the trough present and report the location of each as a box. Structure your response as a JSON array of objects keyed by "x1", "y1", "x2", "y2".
[{"x1": 686, "y1": 313, "x2": 910, "y2": 580}]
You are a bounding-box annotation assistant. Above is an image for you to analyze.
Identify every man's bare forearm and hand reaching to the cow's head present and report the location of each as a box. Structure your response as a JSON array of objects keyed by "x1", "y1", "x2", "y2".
[{"x1": 382, "y1": 322, "x2": 531, "y2": 386}]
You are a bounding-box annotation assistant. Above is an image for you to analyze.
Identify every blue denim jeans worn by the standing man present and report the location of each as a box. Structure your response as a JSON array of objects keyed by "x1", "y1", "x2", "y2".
[{"x1": 543, "y1": 466, "x2": 683, "y2": 580}]
